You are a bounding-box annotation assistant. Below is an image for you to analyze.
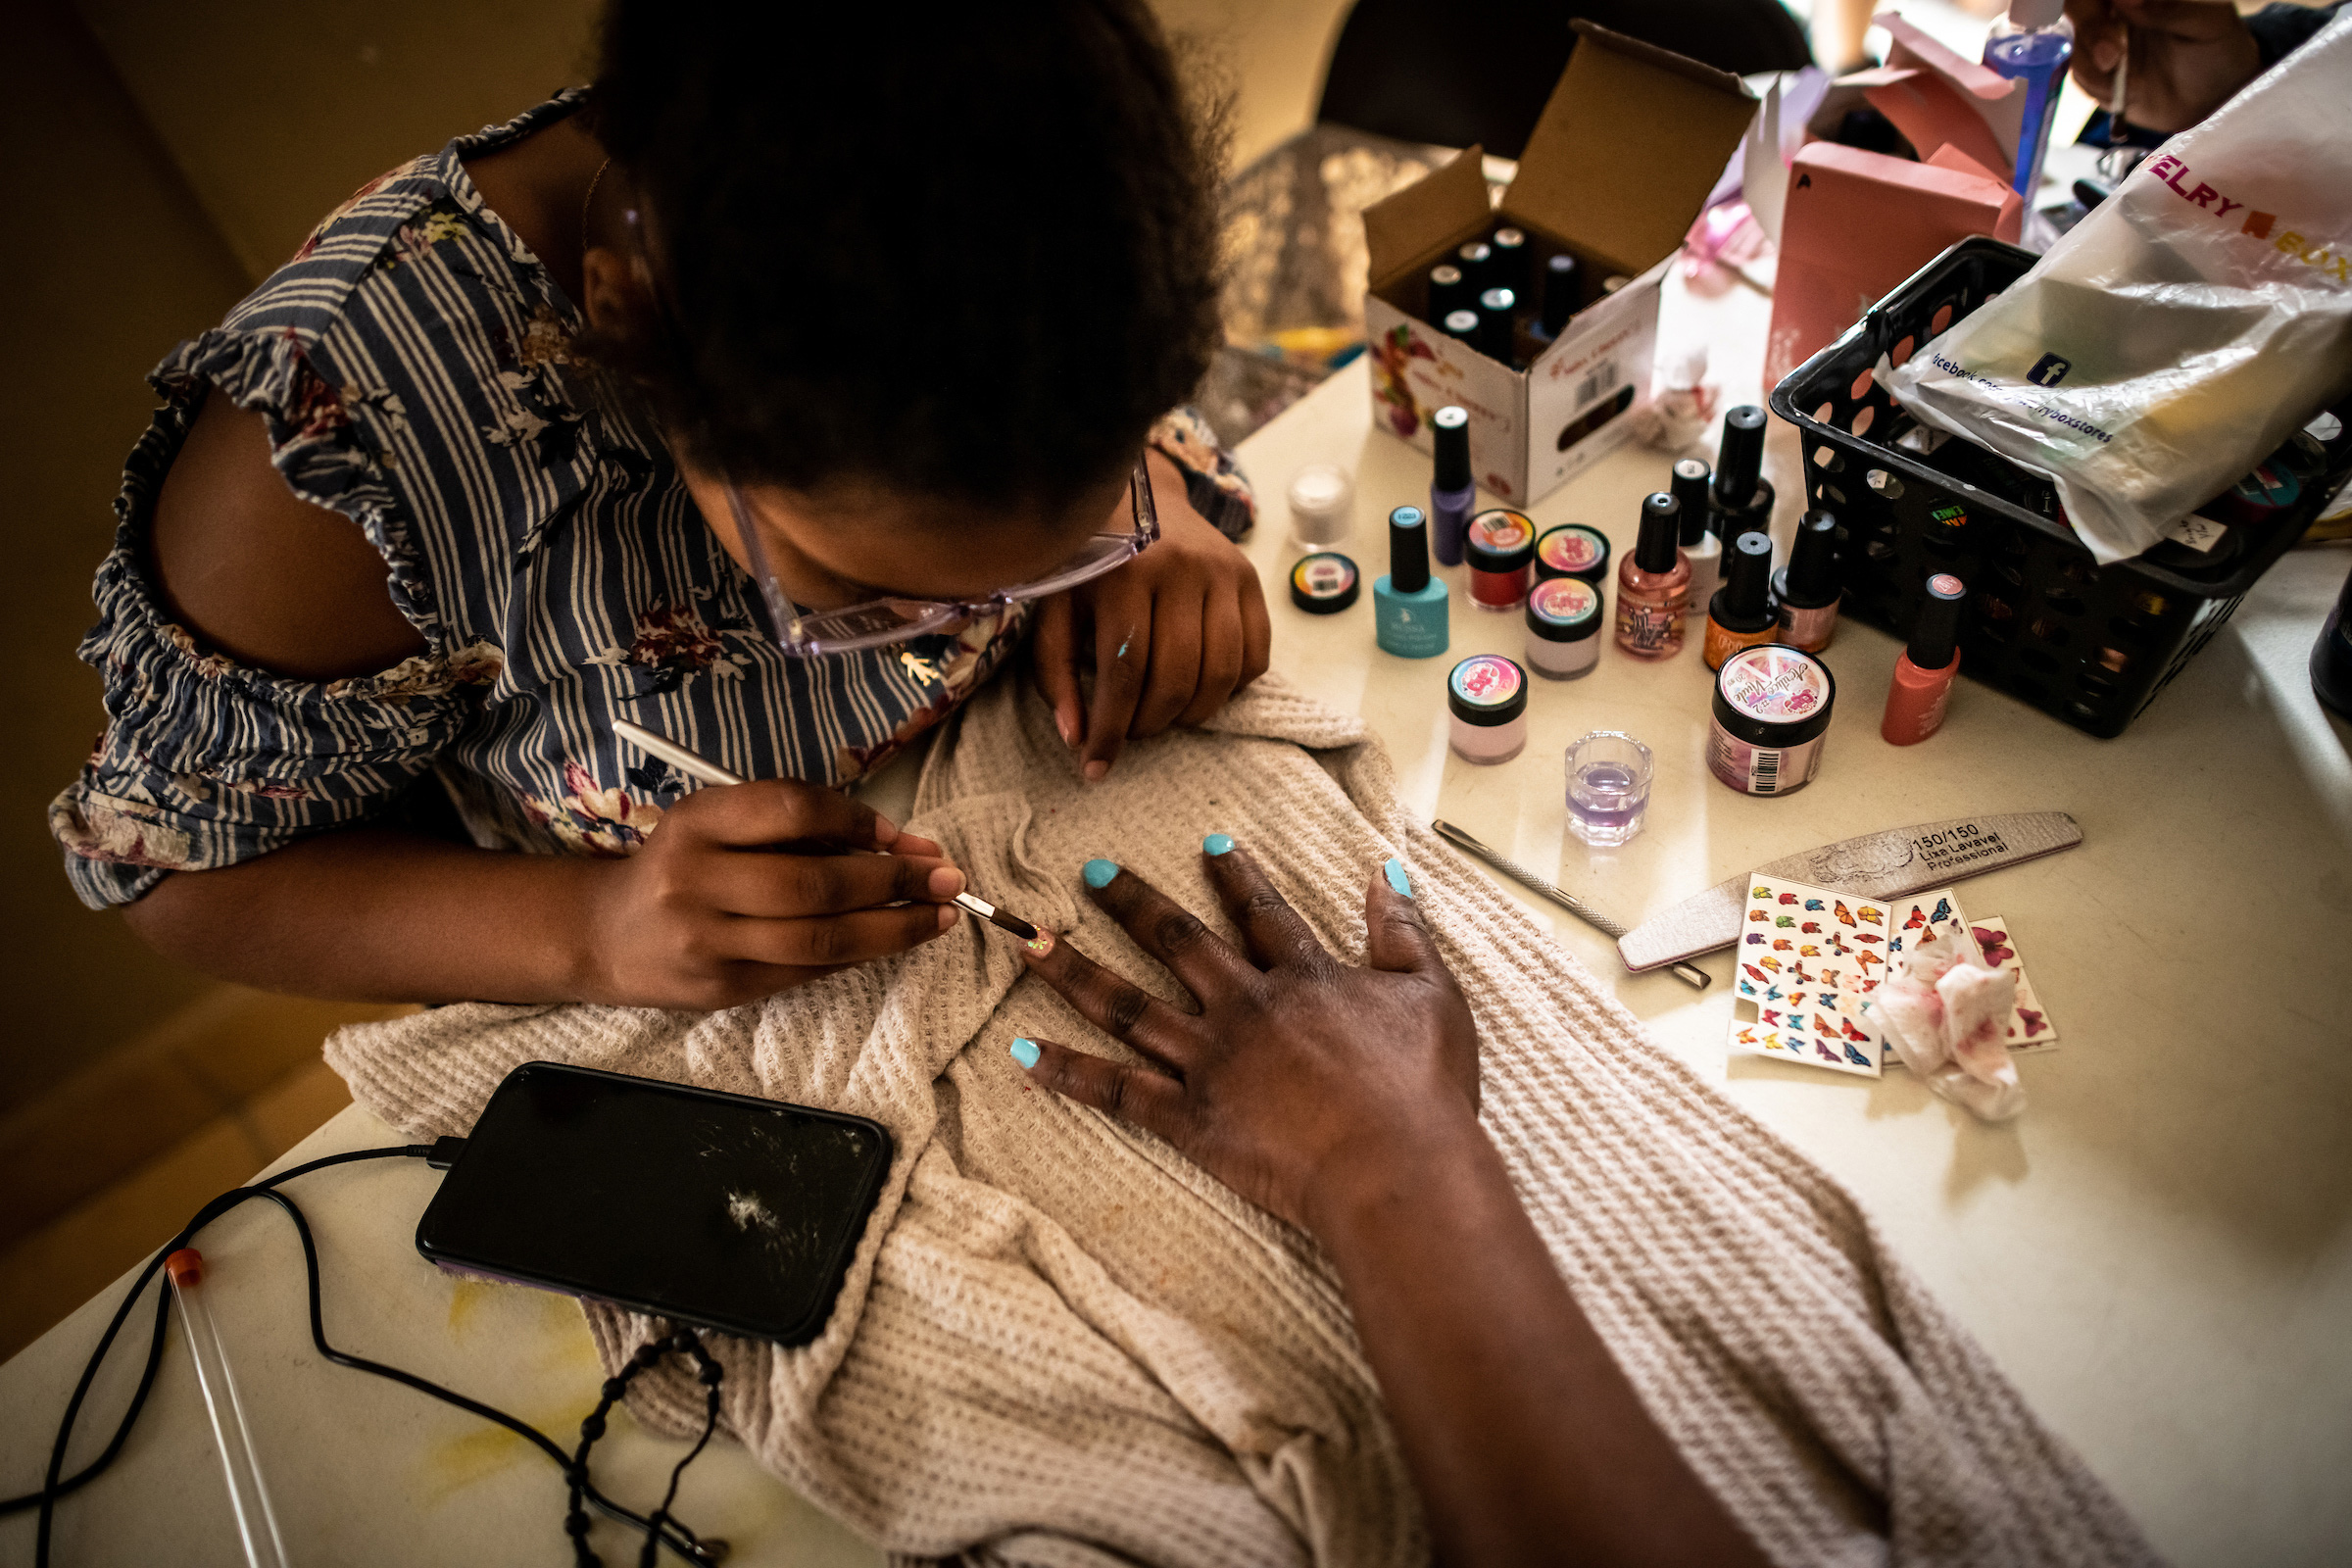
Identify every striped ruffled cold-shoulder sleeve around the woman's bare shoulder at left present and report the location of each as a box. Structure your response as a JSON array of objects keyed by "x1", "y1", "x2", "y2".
[{"x1": 49, "y1": 329, "x2": 501, "y2": 907}]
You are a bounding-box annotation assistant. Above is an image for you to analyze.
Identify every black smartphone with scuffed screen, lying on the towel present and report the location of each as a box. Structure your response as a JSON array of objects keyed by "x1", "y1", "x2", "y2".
[{"x1": 416, "y1": 1062, "x2": 892, "y2": 1345}]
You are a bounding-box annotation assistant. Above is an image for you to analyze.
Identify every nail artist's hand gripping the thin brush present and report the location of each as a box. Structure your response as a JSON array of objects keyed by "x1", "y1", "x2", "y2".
[{"x1": 581, "y1": 778, "x2": 964, "y2": 1008}]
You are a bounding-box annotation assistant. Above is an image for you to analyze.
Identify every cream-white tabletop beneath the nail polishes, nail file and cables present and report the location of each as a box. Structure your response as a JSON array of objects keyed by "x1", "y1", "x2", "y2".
[{"x1": 0, "y1": 272, "x2": 2352, "y2": 1566}]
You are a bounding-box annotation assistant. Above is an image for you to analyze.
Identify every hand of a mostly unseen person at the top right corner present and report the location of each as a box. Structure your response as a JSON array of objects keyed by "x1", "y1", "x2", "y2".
[{"x1": 2065, "y1": 0, "x2": 2263, "y2": 134}]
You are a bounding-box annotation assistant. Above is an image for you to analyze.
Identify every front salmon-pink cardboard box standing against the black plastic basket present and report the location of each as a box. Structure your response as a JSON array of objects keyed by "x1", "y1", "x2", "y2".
[{"x1": 1764, "y1": 141, "x2": 2025, "y2": 385}]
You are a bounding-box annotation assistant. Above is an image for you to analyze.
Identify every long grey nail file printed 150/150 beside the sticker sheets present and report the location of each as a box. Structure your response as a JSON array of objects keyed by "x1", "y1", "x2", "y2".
[{"x1": 1618, "y1": 811, "x2": 2082, "y2": 973}]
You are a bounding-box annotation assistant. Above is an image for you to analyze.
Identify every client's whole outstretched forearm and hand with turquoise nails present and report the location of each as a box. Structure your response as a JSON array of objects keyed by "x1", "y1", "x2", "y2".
[{"x1": 1013, "y1": 835, "x2": 1764, "y2": 1568}]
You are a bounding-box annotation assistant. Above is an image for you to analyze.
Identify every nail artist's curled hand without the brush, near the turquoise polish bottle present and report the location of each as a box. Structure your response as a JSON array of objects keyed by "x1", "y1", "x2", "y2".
[{"x1": 1030, "y1": 452, "x2": 1272, "y2": 780}]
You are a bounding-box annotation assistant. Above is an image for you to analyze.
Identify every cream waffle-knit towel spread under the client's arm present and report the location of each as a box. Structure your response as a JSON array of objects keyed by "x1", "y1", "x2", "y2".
[{"x1": 327, "y1": 679, "x2": 2152, "y2": 1568}]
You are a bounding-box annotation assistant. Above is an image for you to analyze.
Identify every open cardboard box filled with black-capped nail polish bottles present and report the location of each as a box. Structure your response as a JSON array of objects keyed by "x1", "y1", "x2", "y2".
[{"x1": 1364, "y1": 22, "x2": 1757, "y2": 506}]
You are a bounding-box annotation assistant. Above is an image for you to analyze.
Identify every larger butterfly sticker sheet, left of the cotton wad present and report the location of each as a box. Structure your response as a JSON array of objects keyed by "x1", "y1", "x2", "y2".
[{"x1": 1731, "y1": 877, "x2": 1934, "y2": 1079}]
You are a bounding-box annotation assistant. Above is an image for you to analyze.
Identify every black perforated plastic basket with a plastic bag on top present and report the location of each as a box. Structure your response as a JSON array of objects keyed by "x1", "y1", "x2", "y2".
[{"x1": 1771, "y1": 240, "x2": 2352, "y2": 736}]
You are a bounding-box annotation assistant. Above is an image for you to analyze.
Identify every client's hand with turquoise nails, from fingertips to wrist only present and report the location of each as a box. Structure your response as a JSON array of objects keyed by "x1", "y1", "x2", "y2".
[{"x1": 1016, "y1": 835, "x2": 1480, "y2": 1232}]
